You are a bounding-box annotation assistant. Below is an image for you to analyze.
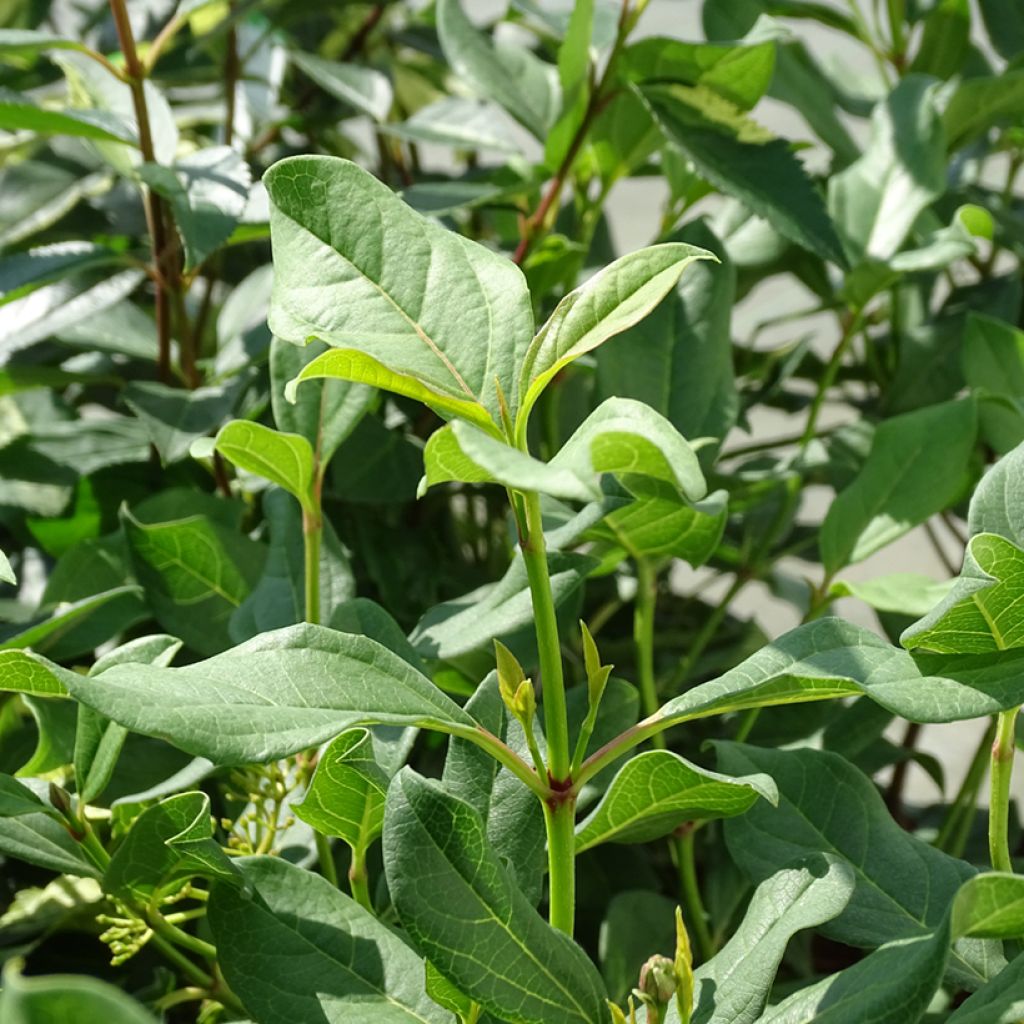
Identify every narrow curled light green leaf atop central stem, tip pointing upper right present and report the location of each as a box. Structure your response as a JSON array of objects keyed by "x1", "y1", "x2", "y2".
[{"x1": 517, "y1": 242, "x2": 718, "y2": 426}]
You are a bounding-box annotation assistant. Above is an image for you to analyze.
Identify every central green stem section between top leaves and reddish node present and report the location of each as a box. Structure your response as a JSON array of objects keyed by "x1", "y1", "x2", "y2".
[{"x1": 521, "y1": 492, "x2": 569, "y2": 782}]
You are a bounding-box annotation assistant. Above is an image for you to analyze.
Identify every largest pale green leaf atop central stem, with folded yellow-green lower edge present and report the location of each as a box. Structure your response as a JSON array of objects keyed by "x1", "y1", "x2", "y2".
[{"x1": 265, "y1": 157, "x2": 532, "y2": 431}]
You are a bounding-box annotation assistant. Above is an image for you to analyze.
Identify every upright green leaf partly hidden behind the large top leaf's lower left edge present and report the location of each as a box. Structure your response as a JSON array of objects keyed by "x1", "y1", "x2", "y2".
[{"x1": 270, "y1": 338, "x2": 376, "y2": 466}]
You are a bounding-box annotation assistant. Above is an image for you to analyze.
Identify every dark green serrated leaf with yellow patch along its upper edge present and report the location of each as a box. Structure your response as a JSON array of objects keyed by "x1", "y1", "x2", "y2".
[{"x1": 643, "y1": 85, "x2": 846, "y2": 266}]
